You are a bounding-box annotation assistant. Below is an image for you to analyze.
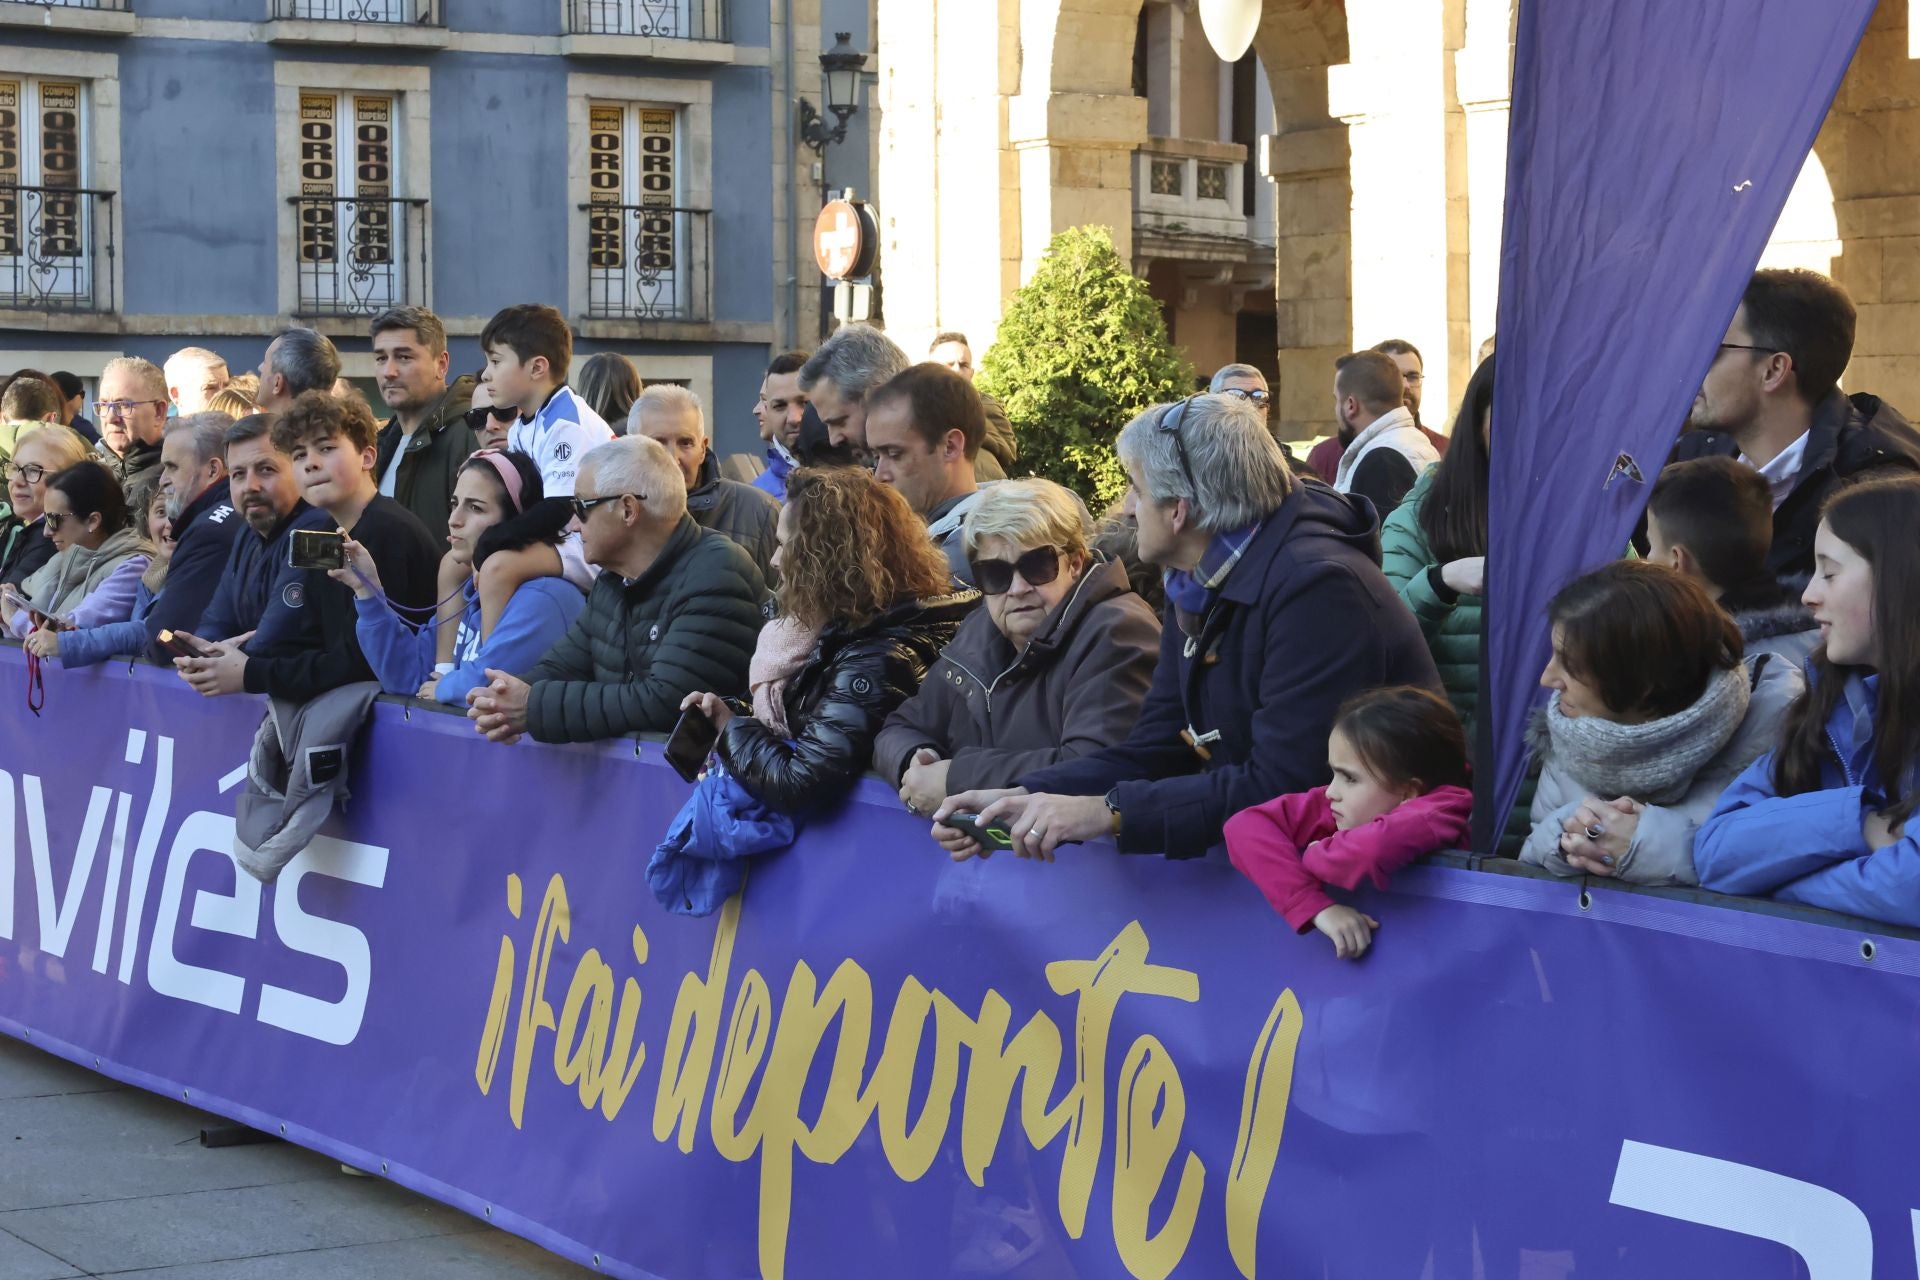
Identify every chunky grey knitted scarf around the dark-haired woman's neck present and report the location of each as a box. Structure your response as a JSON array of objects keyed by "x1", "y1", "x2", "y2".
[{"x1": 1546, "y1": 666, "x2": 1753, "y2": 804}]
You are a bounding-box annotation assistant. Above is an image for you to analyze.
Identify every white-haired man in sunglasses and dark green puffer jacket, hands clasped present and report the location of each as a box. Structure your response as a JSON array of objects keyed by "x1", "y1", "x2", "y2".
[{"x1": 467, "y1": 436, "x2": 772, "y2": 743}]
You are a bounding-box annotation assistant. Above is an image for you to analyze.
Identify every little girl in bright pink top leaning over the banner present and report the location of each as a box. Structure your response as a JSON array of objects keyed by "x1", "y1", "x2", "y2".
[{"x1": 1227, "y1": 685, "x2": 1473, "y2": 960}]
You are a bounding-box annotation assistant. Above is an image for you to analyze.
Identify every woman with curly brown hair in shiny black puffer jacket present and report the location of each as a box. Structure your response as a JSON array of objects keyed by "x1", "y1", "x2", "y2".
[{"x1": 684, "y1": 466, "x2": 981, "y2": 814}]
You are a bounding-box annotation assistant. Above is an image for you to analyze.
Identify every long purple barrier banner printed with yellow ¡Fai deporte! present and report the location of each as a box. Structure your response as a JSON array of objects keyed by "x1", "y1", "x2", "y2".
[{"x1": 0, "y1": 649, "x2": 1920, "y2": 1280}]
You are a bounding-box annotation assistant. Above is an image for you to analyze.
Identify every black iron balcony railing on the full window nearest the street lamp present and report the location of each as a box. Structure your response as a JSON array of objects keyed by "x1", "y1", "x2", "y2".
[{"x1": 580, "y1": 203, "x2": 712, "y2": 320}]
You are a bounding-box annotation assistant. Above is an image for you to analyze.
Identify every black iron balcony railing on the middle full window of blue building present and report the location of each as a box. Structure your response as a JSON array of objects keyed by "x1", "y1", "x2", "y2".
[{"x1": 290, "y1": 196, "x2": 426, "y2": 317}]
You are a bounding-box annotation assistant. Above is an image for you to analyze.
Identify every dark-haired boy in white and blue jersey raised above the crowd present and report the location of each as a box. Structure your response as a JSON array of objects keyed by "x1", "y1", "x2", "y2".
[{"x1": 480, "y1": 303, "x2": 612, "y2": 497}]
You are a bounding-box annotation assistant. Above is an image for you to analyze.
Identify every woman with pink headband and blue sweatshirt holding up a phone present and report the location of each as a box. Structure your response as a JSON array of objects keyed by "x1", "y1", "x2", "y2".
[{"x1": 332, "y1": 449, "x2": 586, "y2": 708}]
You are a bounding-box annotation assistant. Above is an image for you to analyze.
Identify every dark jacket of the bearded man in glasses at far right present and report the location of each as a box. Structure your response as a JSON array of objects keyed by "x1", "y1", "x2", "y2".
[{"x1": 1672, "y1": 390, "x2": 1920, "y2": 593}]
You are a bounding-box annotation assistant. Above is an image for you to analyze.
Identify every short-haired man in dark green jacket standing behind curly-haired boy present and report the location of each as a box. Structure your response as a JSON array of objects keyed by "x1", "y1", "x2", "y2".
[{"x1": 372, "y1": 307, "x2": 480, "y2": 551}]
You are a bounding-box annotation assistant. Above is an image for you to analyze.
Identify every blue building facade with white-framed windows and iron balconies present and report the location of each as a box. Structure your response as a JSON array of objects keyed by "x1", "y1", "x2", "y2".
[{"x1": 0, "y1": 0, "x2": 840, "y2": 453}]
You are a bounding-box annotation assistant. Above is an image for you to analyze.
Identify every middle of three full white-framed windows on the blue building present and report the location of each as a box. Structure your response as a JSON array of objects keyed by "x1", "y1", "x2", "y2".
[{"x1": 292, "y1": 88, "x2": 426, "y2": 315}]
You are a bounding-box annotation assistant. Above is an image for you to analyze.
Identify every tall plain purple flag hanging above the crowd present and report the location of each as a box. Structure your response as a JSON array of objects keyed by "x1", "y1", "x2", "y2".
[{"x1": 1475, "y1": 0, "x2": 1874, "y2": 850}]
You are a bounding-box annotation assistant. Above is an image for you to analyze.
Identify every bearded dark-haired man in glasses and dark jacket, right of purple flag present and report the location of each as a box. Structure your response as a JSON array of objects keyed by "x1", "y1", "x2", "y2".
[{"x1": 1674, "y1": 271, "x2": 1920, "y2": 591}]
